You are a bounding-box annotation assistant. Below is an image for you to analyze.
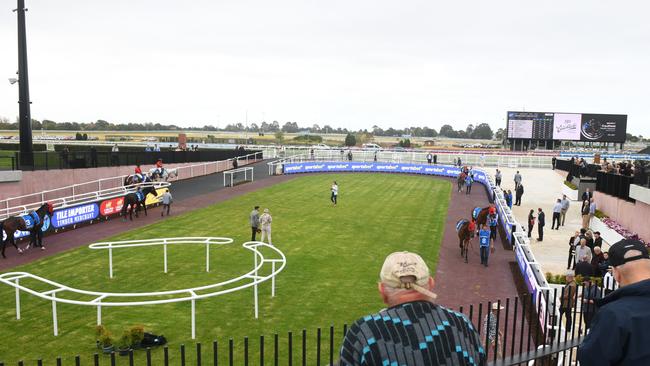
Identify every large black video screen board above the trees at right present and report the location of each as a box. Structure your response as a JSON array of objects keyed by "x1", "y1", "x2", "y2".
[{"x1": 507, "y1": 112, "x2": 627, "y2": 142}]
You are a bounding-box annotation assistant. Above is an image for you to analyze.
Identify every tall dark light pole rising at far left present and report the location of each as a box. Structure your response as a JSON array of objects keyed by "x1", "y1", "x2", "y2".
[{"x1": 14, "y1": 0, "x2": 34, "y2": 166}]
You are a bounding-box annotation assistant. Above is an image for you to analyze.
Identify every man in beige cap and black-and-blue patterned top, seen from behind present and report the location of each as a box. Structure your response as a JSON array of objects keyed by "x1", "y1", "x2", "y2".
[{"x1": 339, "y1": 252, "x2": 486, "y2": 366}]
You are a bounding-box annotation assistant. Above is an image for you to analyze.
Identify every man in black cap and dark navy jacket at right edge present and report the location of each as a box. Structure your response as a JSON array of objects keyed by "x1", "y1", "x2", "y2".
[{"x1": 578, "y1": 240, "x2": 650, "y2": 366}]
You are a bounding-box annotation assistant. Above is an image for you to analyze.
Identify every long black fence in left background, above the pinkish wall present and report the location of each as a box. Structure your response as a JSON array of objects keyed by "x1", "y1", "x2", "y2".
[{"x1": 11, "y1": 149, "x2": 258, "y2": 170}]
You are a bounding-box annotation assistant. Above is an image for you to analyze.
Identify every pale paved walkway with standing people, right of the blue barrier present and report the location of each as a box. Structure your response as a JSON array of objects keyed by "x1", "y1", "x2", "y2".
[{"x1": 487, "y1": 167, "x2": 582, "y2": 274}]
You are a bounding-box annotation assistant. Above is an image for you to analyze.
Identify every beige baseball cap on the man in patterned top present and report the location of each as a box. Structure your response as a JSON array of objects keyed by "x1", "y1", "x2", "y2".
[{"x1": 379, "y1": 252, "x2": 437, "y2": 299}]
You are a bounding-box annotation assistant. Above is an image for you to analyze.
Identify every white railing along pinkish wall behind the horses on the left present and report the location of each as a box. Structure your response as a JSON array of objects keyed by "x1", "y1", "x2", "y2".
[{"x1": 0, "y1": 152, "x2": 263, "y2": 220}]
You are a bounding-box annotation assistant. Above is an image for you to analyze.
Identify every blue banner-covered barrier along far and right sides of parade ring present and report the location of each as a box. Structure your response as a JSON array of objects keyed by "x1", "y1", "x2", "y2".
[{"x1": 268, "y1": 156, "x2": 559, "y2": 342}]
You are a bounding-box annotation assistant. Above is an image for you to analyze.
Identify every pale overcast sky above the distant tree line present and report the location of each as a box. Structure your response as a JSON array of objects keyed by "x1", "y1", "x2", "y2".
[{"x1": 0, "y1": 0, "x2": 650, "y2": 136}]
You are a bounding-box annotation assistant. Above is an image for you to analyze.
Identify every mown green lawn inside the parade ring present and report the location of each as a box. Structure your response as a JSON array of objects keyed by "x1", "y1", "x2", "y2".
[{"x1": 0, "y1": 174, "x2": 451, "y2": 364}]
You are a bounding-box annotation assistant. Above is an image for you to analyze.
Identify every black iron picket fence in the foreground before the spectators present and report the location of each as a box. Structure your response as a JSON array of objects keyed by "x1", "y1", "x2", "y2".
[{"x1": 0, "y1": 286, "x2": 604, "y2": 366}]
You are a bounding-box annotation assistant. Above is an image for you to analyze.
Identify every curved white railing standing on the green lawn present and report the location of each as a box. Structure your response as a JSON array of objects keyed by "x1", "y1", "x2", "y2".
[{"x1": 0, "y1": 237, "x2": 286, "y2": 339}]
